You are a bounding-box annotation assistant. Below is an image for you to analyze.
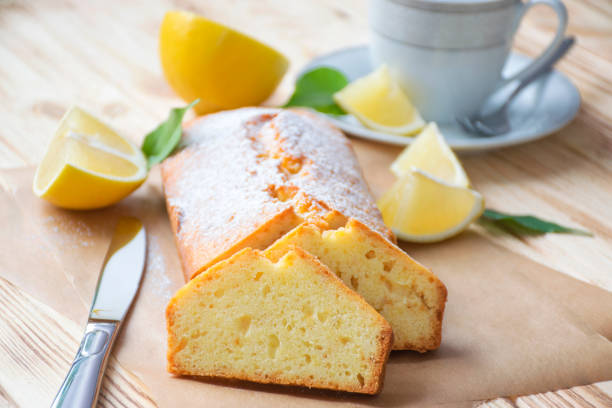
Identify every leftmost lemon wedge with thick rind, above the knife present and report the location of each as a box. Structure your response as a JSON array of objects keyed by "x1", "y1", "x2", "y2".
[{"x1": 33, "y1": 107, "x2": 147, "y2": 210}]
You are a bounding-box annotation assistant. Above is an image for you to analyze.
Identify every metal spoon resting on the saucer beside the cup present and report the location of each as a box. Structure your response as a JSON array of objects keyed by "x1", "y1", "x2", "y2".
[{"x1": 456, "y1": 37, "x2": 576, "y2": 136}]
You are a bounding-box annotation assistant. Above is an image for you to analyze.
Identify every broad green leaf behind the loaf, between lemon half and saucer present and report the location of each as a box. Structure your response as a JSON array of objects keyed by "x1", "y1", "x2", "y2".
[{"x1": 283, "y1": 67, "x2": 348, "y2": 115}]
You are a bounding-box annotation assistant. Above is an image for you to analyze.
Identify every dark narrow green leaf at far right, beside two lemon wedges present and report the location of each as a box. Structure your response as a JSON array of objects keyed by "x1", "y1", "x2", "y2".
[{"x1": 480, "y1": 209, "x2": 593, "y2": 236}]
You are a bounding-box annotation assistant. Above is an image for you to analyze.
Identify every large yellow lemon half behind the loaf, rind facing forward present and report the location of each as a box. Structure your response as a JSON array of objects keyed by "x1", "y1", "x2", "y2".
[{"x1": 159, "y1": 11, "x2": 289, "y2": 114}]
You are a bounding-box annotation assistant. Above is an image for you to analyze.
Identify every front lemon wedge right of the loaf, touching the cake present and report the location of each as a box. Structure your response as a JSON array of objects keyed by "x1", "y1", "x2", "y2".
[{"x1": 378, "y1": 168, "x2": 484, "y2": 242}]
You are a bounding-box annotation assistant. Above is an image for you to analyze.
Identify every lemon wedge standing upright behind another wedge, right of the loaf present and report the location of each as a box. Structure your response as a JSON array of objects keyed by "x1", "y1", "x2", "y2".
[{"x1": 391, "y1": 122, "x2": 470, "y2": 187}]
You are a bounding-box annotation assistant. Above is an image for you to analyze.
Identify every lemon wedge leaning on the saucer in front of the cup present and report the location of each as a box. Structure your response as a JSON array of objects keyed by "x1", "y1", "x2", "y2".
[{"x1": 334, "y1": 65, "x2": 425, "y2": 136}]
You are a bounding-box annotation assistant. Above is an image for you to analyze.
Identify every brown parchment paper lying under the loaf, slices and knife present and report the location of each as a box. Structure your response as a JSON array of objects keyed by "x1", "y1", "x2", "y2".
[{"x1": 0, "y1": 169, "x2": 612, "y2": 407}]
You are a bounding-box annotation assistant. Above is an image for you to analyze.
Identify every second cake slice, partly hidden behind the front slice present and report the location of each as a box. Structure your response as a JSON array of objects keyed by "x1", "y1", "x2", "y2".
[{"x1": 264, "y1": 219, "x2": 446, "y2": 352}]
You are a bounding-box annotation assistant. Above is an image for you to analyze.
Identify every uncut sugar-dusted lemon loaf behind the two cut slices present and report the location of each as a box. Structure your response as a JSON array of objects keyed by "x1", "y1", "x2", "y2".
[{"x1": 162, "y1": 108, "x2": 394, "y2": 279}]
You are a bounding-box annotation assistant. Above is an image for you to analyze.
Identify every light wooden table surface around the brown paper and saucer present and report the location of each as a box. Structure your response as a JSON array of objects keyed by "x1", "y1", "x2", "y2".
[{"x1": 0, "y1": 0, "x2": 612, "y2": 407}]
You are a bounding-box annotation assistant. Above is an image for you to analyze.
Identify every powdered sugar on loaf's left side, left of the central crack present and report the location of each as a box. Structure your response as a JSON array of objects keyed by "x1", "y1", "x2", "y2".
[{"x1": 163, "y1": 109, "x2": 289, "y2": 276}]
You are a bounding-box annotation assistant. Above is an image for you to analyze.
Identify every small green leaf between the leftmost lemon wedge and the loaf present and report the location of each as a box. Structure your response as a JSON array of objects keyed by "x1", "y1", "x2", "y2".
[{"x1": 140, "y1": 99, "x2": 200, "y2": 169}]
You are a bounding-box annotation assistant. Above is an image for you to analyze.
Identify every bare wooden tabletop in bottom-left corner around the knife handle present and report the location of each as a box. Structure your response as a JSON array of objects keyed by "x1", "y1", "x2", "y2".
[{"x1": 0, "y1": 278, "x2": 156, "y2": 408}]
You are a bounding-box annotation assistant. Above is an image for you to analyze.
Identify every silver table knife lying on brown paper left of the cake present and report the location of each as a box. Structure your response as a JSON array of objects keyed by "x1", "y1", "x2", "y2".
[{"x1": 51, "y1": 217, "x2": 147, "y2": 408}]
